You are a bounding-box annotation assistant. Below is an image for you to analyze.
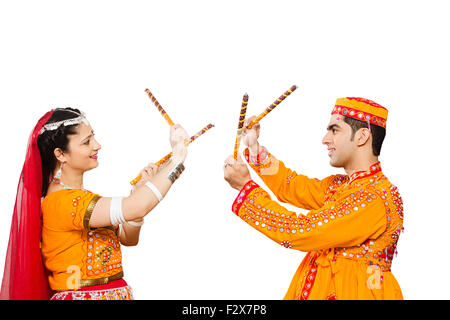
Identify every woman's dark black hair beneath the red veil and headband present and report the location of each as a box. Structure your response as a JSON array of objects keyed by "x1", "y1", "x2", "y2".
[{"x1": 37, "y1": 108, "x2": 81, "y2": 197}]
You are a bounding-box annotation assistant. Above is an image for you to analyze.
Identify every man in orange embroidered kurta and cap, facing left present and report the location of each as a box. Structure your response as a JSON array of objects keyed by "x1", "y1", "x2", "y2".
[{"x1": 224, "y1": 98, "x2": 403, "y2": 299}]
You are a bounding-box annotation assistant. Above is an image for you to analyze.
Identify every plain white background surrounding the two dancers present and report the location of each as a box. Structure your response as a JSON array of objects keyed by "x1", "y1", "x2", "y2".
[{"x1": 0, "y1": 0, "x2": 450, "y2": 299}]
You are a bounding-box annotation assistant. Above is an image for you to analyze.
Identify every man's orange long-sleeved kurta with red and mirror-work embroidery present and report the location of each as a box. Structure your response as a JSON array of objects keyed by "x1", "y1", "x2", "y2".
[{"x1": 232, "y1": 149, "x2": 403, "y2": 299}]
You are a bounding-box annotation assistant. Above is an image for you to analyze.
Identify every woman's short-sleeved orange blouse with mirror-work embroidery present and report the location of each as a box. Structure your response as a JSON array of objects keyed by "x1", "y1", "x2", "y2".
[{"x1": 41, "y1": 189, "x2": 123, "y2": 290}]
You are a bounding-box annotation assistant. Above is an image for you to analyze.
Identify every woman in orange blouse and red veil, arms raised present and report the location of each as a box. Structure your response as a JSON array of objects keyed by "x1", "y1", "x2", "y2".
[{"x1": 0, "y1": 108, "x2": 188, "y2": 300}]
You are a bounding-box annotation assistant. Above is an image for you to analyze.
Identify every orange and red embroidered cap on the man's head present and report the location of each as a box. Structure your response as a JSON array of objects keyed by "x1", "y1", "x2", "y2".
[{"x1": 331, "y1": 97, "x2": 388, "y2": 128}]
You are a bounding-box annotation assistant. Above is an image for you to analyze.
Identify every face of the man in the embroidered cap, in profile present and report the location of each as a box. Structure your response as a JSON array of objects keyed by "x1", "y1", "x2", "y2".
[{"x1": 322, "y1": 114, "x2": 357, "y2": 168}]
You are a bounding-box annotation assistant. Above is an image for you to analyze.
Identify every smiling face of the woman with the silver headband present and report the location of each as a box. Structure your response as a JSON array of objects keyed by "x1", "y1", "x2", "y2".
[{"x1": 59, "y1": 123, "x2": 102, "y2": 172}]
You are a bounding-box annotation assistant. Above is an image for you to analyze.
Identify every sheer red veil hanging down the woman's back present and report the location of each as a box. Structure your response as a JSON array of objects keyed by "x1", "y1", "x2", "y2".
[{"x1": 0, "y1": 110, "x2": 53, "y2": 300}]
